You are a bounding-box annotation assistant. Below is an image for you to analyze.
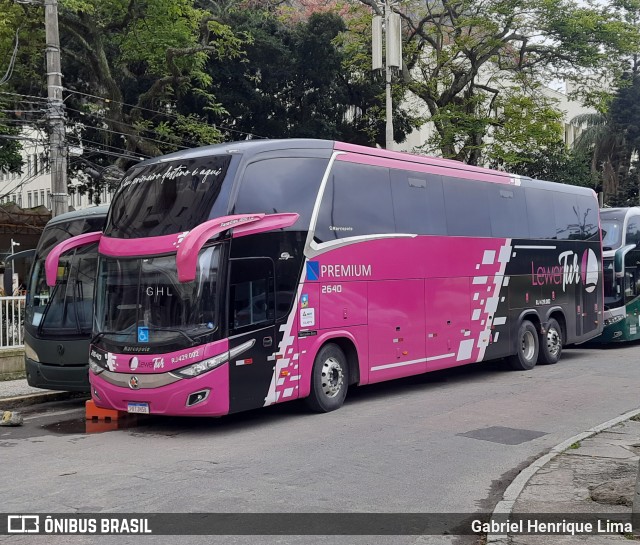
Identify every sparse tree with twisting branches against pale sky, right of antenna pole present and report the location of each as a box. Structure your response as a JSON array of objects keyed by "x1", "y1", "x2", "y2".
[{"x1": 361, "y1": 0, "x2": 638, "y2": 164}]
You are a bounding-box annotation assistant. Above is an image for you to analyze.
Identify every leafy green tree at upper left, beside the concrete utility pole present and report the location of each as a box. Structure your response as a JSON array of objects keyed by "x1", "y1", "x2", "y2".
[{"x1": 0, "y1": 0, "x2": 249, "y2": 202}]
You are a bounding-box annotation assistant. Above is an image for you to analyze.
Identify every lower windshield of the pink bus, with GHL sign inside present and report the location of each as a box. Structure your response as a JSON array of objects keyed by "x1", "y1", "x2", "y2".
[{"x1": 95, "y1": 245, "x2": 220, "y2": 346}]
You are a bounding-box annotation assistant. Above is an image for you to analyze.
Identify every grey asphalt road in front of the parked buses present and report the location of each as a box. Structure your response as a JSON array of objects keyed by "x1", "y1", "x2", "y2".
[{"x1": 0, "y1": 344, "x2": 640, "y2": 544}]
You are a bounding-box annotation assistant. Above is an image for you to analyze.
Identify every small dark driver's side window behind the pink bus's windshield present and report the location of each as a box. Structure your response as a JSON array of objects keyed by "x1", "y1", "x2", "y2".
[{"x1": 229, "y1": 258, "x2": 275, "y2": 330}]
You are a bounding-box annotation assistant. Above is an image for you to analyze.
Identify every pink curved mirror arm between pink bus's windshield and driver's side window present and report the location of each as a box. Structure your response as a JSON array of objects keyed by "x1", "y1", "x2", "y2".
[{"x1": 176, "y1": 214, "x2": 299, "y2": 282}]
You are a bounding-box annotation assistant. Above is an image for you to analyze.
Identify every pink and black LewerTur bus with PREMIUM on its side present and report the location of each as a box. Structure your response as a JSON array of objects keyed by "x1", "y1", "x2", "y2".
[{"x1": 47, "y1": 139, "x2": 603, "y2": 416}]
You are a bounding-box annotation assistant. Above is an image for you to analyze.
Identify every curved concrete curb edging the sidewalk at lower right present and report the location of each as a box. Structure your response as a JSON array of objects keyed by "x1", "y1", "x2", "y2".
[{"x1": 486, "y1": 408, "x2": 640, "y2": 545}]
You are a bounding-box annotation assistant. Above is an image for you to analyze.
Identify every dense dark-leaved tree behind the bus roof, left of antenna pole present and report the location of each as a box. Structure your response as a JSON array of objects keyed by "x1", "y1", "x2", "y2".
[{"x1": 208, "y1": 3, "x2": 415, "y2": 145}]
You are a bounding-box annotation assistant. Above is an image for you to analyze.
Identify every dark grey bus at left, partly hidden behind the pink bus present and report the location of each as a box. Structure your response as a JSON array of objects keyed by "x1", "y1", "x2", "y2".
[{"x1": 16, "y1": 206, "x2": 108, "y2": 392}]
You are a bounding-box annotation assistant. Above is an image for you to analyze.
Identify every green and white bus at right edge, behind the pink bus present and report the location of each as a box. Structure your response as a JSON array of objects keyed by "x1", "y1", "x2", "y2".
[{"x1": 595, "y1": 206, "x2": 640, "y2": 344}]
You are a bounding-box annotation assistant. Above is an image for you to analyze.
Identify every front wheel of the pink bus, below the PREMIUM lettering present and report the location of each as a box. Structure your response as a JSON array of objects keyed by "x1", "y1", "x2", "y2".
[{"x1": 306, "y1": 343, "x2": 349, "y2": 413}]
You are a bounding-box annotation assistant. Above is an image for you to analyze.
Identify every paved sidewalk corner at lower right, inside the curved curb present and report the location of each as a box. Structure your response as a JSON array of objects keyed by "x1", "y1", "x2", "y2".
[{"x1": 487, "y1": 410, "x2": 640, "y2": 545}]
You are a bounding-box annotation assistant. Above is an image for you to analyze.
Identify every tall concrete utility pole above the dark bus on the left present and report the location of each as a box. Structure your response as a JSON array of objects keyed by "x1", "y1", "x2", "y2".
[{"x1": 44, "y1": 0, "x2": 69, "y2": 217}]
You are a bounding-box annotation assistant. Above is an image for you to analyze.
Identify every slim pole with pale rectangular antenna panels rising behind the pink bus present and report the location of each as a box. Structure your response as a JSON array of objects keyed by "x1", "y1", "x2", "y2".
[{"x1": 371, "y1": 0, "x2": 402, "y2": 150}]
